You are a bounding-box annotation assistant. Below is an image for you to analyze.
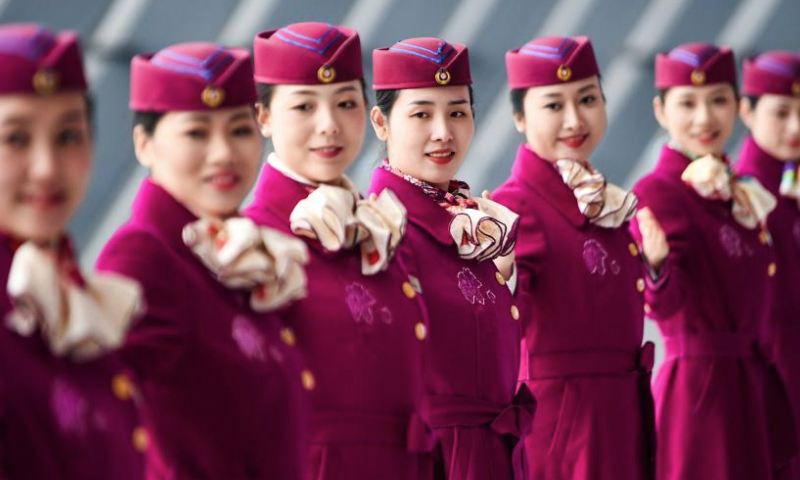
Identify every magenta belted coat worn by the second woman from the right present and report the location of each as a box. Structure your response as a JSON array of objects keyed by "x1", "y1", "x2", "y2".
[{"x1": 634, "y1": 146, "x2": 793, "y2": 480}]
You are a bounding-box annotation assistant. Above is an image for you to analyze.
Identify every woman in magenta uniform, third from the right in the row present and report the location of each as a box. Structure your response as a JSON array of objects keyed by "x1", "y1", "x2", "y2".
[{"x1": 494, "y1": 37, "x2": 654, "y2": 480}]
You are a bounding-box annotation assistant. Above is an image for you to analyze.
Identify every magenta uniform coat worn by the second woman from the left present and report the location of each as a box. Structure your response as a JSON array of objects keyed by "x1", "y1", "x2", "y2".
[{"x1": 97, "y1": 179, "x2": 305, "y2": 480}]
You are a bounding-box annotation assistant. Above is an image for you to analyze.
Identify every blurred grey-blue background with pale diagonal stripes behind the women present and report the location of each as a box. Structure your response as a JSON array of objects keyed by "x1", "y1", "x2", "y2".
[{"x1": 0, "y1": 0, "x2": 800, "y2": 372}]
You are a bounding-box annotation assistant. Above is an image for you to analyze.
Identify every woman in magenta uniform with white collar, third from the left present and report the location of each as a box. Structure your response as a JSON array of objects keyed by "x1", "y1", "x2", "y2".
[{"x1": 246, "y1": 23, "x2": 432, "y2": 480}]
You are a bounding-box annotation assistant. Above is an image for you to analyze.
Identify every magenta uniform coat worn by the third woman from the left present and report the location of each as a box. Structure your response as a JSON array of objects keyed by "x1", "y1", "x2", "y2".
[{"x1": 245, "y1": 164, "x2": 432, "y2": 480}]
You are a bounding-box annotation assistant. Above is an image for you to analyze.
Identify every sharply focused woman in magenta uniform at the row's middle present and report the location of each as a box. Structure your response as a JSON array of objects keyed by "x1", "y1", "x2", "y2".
[{"x1": 370, "y1": 38, "x2": 533, "y2": 480}]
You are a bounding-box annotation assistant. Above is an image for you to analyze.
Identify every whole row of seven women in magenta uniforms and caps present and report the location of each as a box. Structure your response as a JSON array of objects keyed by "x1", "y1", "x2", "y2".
[{"x1": 0, "y1": 17, "x2": 800, "y2": 480}]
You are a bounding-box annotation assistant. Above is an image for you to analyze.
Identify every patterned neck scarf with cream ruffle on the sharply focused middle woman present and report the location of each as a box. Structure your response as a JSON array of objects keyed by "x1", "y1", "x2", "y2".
[{"x1": 381, "y1": 159, "x2": 519, "y2": 262}]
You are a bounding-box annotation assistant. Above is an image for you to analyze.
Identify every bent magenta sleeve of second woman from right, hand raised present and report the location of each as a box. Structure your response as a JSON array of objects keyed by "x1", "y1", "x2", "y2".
[{"x1": 630, "y1": 179, "x2": 692, "y2": 320}]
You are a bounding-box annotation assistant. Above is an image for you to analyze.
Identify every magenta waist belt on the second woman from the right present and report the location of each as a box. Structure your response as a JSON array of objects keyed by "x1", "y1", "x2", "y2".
[{"x1": 664, "y1": 332, "x2": 760, "y2": 360}]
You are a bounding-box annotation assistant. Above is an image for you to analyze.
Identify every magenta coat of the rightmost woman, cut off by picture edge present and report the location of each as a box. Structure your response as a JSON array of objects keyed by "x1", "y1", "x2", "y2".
[{"x1": 736, "y1": 137, "x2": 800, "y2": 479}]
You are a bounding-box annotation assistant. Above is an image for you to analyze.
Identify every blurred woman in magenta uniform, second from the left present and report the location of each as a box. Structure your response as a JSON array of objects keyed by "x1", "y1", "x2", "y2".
[{"x1": 97, "y1": 43, "x2": 306, "y2": 479}]
